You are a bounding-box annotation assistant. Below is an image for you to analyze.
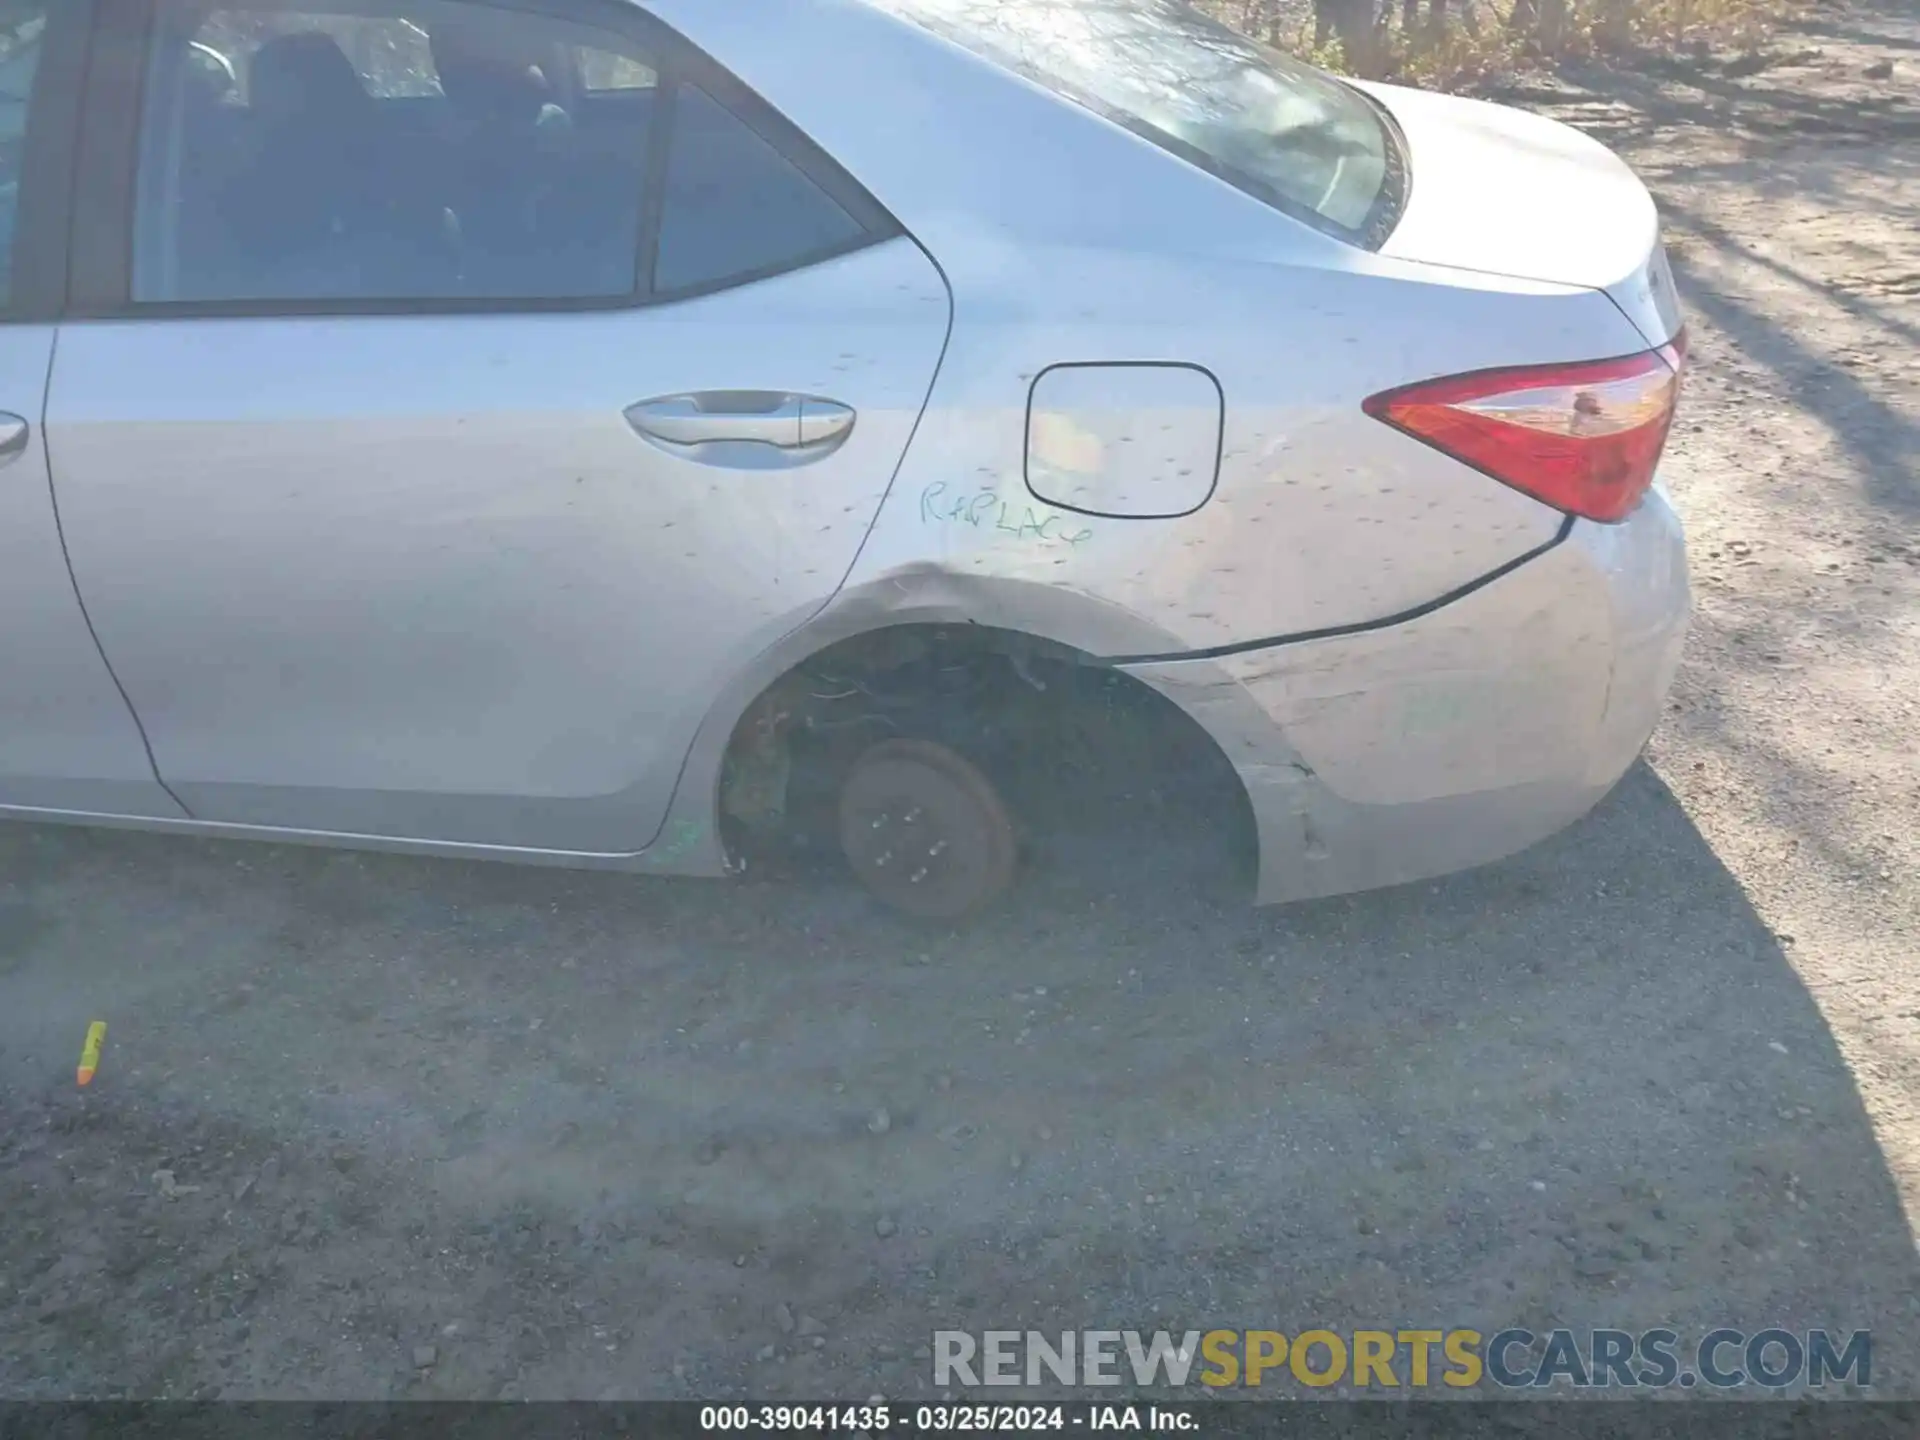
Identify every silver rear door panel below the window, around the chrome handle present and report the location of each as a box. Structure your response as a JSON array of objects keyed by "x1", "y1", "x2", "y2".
[{"x1": 46, "y1": 238, "x2": 948, "y2": 852}]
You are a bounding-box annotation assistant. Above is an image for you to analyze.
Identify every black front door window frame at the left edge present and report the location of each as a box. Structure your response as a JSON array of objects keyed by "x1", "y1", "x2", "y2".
[{"x1": 0, "y1": 0, "x2": 94, "y2": 324}]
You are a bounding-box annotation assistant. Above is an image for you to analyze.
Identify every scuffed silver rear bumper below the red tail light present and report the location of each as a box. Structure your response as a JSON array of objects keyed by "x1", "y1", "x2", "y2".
[{"x1": 1131, "y1": 490, "x2": 1690, "y2": 904}]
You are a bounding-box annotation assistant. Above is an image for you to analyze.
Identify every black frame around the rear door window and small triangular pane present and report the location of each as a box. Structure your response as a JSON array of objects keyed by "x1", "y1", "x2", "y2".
[{"x1": 61, "y1": 0, "x2": 906, "y2": 321}]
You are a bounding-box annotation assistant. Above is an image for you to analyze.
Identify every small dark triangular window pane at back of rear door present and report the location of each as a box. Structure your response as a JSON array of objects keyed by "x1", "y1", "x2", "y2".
[{"x1": 653, "y1": 84, "x2": 864, "y2": 294}]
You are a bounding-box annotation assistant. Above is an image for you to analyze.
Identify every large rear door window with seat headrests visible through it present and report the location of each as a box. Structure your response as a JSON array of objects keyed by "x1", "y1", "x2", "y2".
[{"x1": 133, "y1": 0, "x2": 657, "y2": 303}]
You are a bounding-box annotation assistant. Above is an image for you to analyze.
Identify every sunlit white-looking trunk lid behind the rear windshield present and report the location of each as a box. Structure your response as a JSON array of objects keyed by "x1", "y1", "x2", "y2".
[{"x1": 1361, "y1": 84, "x2": 1680, "y2": 346}]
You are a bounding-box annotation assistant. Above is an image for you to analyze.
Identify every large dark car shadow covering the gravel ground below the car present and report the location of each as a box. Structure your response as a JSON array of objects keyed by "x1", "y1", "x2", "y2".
[{"x1": 0, "y1": 770, "x2": 1920, "y2": 1400}]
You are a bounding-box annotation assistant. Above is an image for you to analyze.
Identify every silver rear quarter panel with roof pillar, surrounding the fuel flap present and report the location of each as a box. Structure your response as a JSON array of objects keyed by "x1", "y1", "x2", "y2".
[{"x1": 655, "y1": 0, "x2": 1640, "y2": 653}]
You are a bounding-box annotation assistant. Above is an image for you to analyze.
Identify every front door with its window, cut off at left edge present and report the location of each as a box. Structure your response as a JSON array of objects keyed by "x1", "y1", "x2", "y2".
[{"x1": 0, "y1": 0, "x2": 180, "y2": 816}]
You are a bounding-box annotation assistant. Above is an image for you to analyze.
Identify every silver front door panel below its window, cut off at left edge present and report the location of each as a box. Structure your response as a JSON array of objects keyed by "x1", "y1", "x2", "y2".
[{"x1": 0, "y1": 324, "x2": 180, "y2": 818}]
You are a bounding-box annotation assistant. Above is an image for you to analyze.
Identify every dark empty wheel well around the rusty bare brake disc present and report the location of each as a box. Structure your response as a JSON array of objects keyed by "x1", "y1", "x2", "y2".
[{"x1": 718, "y1": 624, "x2": 1254, "y2": 890}]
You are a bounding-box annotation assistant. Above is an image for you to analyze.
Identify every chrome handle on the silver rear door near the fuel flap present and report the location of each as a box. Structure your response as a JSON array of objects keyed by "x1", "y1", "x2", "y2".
[{"x1": 626, "y1": 390, "x2": 854, "y2": 468}]
